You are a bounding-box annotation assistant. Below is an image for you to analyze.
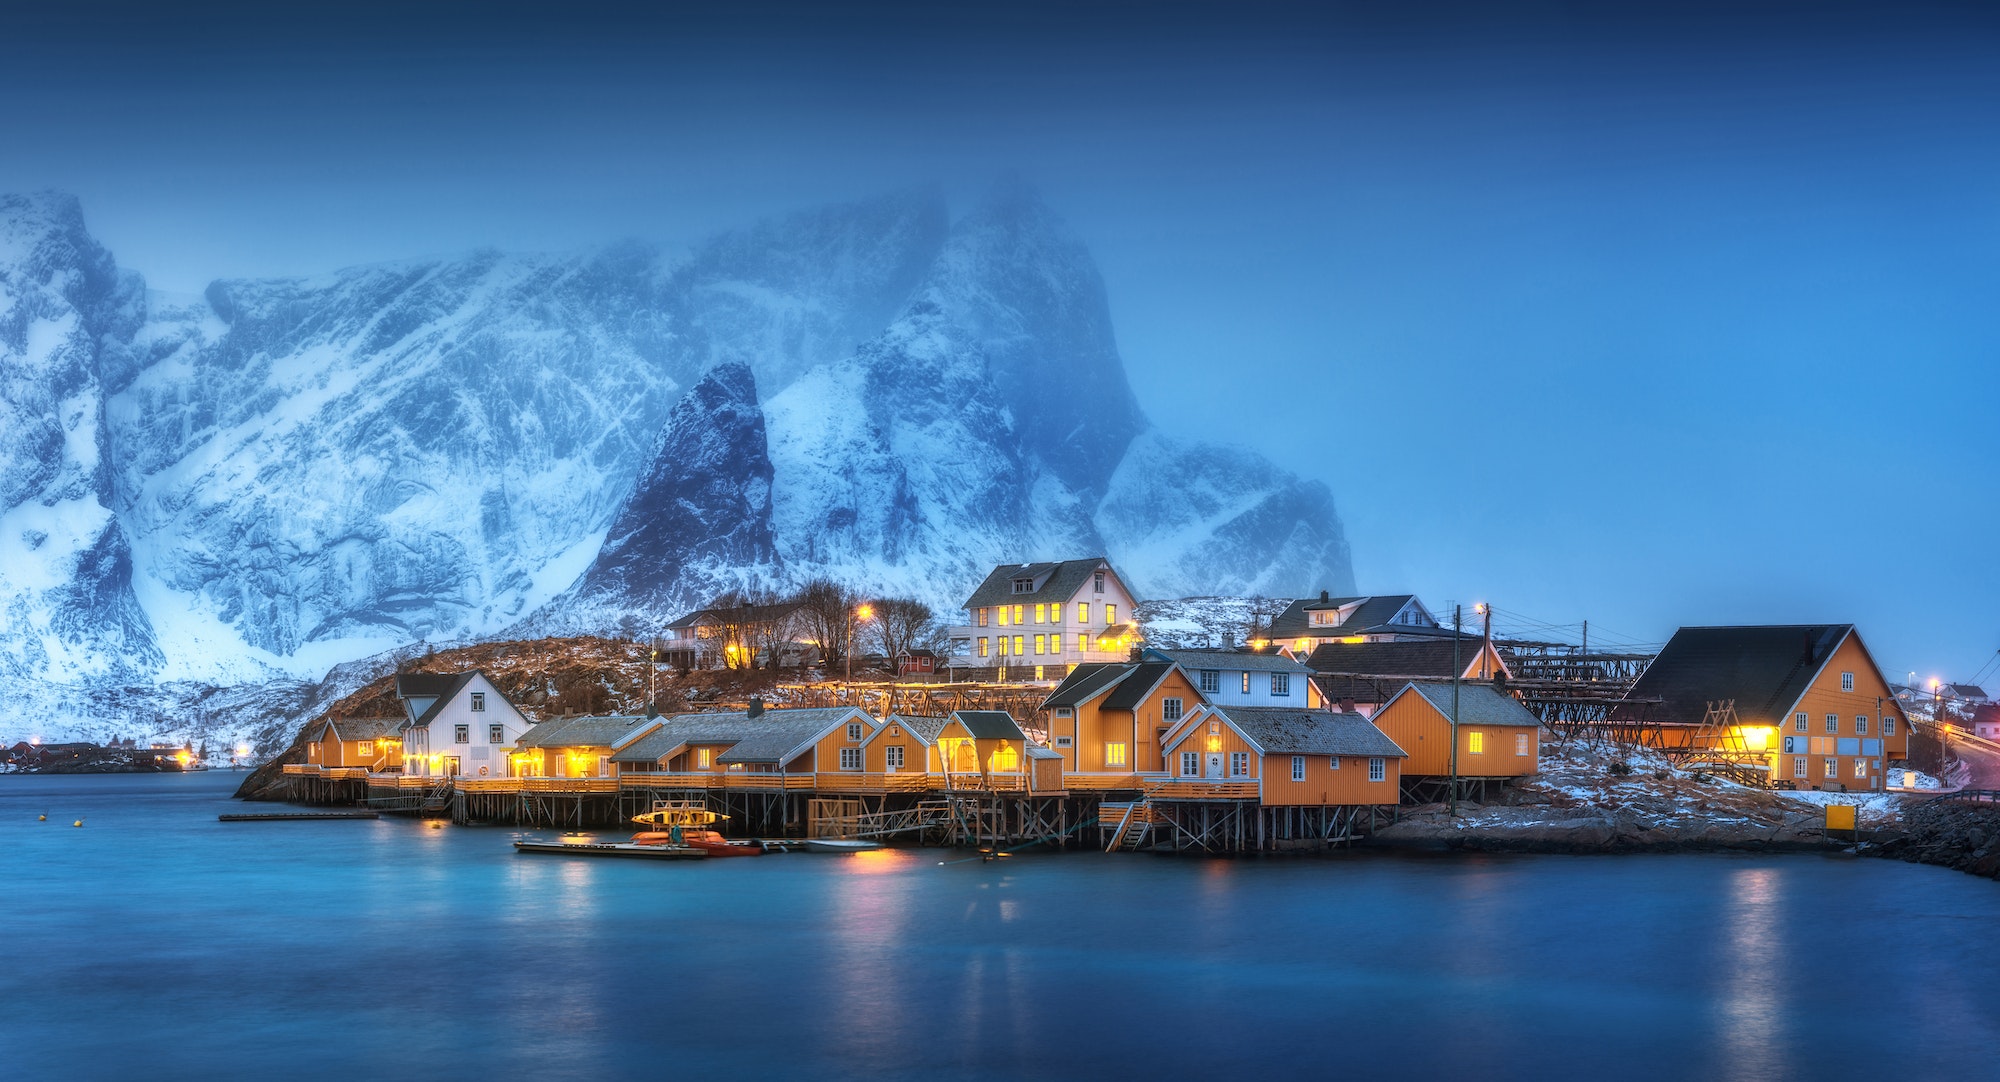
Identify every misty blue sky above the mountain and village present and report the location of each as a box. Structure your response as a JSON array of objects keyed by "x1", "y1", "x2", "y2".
[{"x1": 11, "y1": 2, "x2": 2000, "y2": 684}]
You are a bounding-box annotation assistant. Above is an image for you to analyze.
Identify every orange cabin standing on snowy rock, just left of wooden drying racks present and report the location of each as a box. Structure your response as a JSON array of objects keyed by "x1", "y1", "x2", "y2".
[{"x1": 1372, "y1": 680, "x2": 1542, "y2": 778}]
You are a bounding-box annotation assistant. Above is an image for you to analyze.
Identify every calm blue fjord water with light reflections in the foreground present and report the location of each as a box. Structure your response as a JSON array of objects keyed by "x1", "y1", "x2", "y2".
[{"x1": 0, "y1": 774, "x2": 2000, "y2": 1078}]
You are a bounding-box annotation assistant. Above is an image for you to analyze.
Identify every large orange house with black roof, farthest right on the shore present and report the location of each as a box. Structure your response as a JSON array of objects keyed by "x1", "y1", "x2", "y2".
[{"x1": 1610, "y1": 624, "x2": 1910, "y2": 790}]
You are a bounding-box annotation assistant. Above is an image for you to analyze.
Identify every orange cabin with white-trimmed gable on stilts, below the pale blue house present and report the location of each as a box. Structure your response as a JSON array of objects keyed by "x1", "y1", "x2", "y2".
[{"x1": 1162, "y1": 706, "x2": 1406, "y2": 808}]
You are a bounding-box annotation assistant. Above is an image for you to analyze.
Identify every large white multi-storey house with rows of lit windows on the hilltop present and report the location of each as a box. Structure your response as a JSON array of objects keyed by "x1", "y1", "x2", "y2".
[{"x1": 948, "y1": 556, "x2": 1140, "y2": 678}]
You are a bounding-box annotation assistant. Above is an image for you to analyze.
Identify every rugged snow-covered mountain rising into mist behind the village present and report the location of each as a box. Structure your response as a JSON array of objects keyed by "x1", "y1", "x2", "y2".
[{"x1": 0, "y1": 184, "x2": 1352, "y2": 738}]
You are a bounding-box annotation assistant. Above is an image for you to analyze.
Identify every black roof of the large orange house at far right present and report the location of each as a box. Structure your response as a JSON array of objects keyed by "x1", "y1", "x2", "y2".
[{"x1": 1612, "y1": 624, "x2": 1854, "y2": 724}]
